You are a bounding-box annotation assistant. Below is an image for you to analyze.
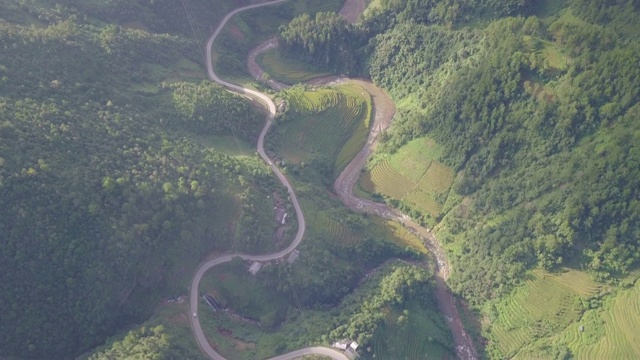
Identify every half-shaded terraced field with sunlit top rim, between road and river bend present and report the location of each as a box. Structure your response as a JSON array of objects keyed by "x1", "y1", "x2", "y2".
[{"x1": 269, "y1": 84, "x2": 371, "y2": 178}]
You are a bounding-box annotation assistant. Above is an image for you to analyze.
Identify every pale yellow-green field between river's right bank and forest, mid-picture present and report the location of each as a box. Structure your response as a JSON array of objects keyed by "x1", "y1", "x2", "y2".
[{"x1": 358, "y1": 138, "x2": 454, "y2": 216}]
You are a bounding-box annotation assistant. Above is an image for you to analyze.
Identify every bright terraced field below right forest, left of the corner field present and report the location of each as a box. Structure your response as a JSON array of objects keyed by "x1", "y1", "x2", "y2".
[{"x1": 489, "y1": 270, "x2": 602, "y2": 358}]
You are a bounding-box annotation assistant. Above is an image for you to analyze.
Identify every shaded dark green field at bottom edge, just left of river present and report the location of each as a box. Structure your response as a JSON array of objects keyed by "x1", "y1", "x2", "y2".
[{"x1": 362, "y1": 301, "x2": 454, "y2": 359}]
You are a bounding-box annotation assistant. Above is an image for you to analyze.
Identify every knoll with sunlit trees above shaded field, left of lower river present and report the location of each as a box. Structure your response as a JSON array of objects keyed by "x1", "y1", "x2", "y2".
[{"x1": 330, "y1": 261, "x2": 452, "y2": 359}]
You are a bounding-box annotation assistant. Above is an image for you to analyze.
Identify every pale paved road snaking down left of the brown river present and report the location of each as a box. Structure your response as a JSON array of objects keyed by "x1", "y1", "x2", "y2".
[{"x1": 189, "y1": 0, "x2": 349, "y2": 360}]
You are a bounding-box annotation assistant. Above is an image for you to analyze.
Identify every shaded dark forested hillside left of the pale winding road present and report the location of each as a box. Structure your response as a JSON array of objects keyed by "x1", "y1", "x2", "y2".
[{"x1": 0, "y1": 0, "x2": 272, "y2": 359}]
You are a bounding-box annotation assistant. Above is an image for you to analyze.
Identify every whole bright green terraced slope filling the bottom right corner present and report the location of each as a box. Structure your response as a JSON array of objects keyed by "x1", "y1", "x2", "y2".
[{"x1": 485, "y1": 269, "x2": 640, "y2": 359}]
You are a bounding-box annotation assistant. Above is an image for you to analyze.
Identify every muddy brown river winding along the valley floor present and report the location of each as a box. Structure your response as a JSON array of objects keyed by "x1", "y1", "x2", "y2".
[{"x1": 247, "y1": 0, "x2": 478, "y2": 360}]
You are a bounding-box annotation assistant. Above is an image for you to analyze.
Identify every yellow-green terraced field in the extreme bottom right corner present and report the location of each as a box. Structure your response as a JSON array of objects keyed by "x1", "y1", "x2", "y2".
[{"x1": 566, "y1": 282, "x2": 640, "y2": 359}]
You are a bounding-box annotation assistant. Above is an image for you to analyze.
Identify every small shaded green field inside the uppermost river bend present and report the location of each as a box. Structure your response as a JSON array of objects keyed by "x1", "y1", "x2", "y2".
[{"x1": 256, "y1": 49, "x2": 332, "y2": 85}]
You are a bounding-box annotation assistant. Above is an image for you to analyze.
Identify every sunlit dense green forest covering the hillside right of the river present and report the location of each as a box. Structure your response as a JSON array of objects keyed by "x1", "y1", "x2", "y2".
[{"x1": 280, "y1": 0, "x2": 640, "y2": 310}]
